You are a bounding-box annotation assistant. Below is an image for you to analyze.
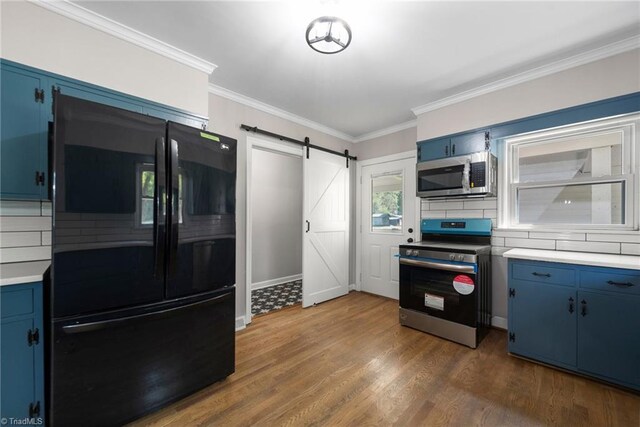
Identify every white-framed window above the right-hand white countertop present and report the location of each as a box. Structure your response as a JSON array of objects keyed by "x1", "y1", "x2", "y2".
[{"x1": 500, "y1": 115, "x2": 640, "y2": 229}]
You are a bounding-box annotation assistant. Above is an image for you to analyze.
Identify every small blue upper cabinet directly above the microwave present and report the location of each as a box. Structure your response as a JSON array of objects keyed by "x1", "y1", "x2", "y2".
[{"x1": 418, "y1": 130, "x2": 490, "y2": 162}]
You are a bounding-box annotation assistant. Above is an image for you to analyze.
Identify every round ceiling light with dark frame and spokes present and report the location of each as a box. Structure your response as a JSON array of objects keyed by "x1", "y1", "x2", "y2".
[{"x1": 306, "y1": 16, "x2": 351, "y2": 54}]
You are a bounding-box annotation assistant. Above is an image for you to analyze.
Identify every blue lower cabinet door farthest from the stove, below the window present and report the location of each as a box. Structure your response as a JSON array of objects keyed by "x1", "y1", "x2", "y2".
[{"x1": 578, "y1": 292, "x2": 640, "y2": 388}]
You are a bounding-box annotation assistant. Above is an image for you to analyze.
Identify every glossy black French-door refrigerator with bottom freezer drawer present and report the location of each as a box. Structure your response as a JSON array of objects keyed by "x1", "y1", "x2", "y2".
[{"x1": 45, "y1": 95, "x2": 236, "y2": 426}]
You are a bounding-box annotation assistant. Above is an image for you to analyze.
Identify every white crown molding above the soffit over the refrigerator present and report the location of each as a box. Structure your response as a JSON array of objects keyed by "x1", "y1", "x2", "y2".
[{"x1": 31, "y1": 0, "x2": 217, "y2": 74}]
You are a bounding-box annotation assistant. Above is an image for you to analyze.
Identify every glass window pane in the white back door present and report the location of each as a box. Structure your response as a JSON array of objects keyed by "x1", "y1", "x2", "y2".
[{"x1": 371, "y1": 171, "x2": 404, "y2": 233}]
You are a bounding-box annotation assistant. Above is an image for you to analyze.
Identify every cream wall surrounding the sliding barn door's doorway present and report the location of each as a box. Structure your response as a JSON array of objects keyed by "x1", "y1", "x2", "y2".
[{"x1": 209, "y1": 93, "x2": 356, "y2": 326}]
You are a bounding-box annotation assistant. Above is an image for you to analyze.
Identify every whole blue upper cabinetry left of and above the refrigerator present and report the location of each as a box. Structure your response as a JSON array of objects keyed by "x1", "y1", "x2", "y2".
[{"x1": 0, "y1": 60, "x2": 207, "y2": 200}]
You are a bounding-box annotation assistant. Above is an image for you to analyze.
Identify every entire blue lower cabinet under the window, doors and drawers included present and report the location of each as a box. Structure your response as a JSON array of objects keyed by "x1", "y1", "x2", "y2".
[{"x1": 508, "y1": 259, "x2": 640, "y2": 390}]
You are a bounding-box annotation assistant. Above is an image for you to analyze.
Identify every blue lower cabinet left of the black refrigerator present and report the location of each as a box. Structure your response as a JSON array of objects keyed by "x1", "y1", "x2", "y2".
[{"x1": 0, "y1": 282, "x2": 44, "y2": 425}]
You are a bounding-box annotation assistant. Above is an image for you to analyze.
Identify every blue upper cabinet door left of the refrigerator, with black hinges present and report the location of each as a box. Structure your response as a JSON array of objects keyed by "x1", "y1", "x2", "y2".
[{"x1": 0, "y1": 66, "x2": 49, "y2": 200}]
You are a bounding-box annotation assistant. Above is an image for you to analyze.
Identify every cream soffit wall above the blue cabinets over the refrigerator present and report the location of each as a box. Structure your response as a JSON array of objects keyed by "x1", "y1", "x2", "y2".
[{"x1": 0, "y1": 1, "x2": 208, "y2": 116}]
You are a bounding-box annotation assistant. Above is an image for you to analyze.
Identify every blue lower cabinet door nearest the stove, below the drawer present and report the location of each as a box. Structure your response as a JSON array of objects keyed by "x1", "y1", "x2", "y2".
[{"x1": 509, "y1": 280, "x2": 576, "y2": 367}]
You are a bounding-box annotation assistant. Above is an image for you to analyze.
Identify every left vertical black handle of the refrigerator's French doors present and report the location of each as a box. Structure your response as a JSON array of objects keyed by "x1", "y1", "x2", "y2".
[{"x1": 153, "y1": 138, "x2": 167, "y2": 279}]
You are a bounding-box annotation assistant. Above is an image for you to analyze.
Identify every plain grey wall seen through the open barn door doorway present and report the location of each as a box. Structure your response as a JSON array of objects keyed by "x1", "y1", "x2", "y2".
[{"x1": 250, "y1": 148, "x2": 302, "y2": 285}]
